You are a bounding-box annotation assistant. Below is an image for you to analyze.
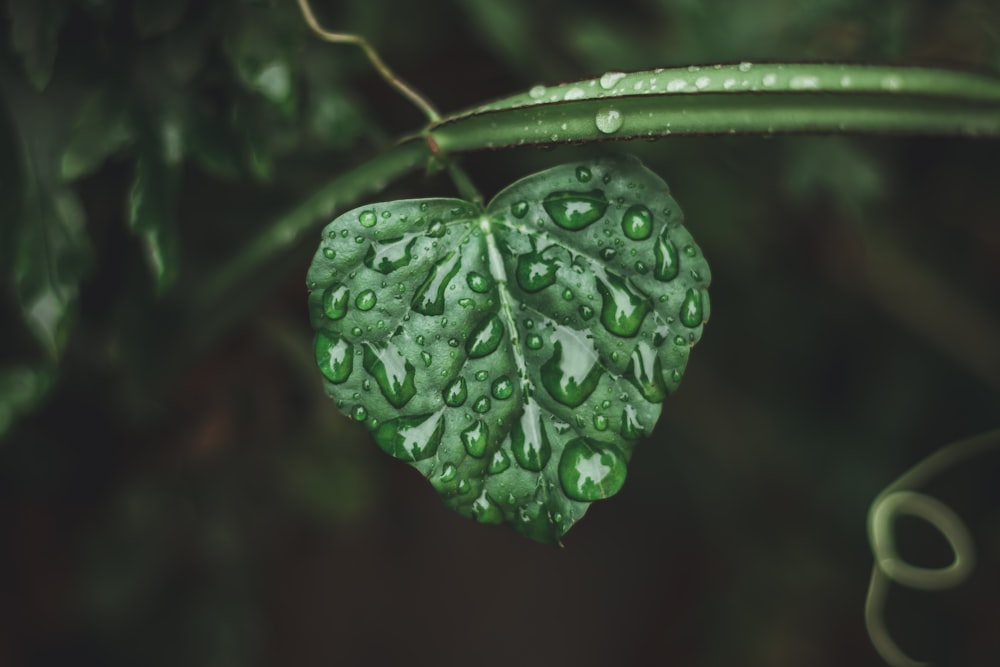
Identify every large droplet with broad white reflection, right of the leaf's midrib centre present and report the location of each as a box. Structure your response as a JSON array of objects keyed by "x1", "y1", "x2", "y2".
[{"x1": 541, "y1": 328, "x2": 601, "y2": 408}]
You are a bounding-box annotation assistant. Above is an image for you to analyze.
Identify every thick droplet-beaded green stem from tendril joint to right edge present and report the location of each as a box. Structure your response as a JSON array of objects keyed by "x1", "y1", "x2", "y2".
[{"x1": 430, "y1": 63, "x2": 1000, "y2": 153}]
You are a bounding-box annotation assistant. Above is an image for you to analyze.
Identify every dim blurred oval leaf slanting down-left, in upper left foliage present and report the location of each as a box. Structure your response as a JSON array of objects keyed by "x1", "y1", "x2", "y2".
[{"x1": 59, "y1": 90, "x2": 134, "y2": 181}]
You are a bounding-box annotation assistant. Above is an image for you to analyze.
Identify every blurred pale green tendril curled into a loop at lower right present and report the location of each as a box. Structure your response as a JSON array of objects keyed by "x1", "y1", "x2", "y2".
[{"x1": 865, "y1": 430, "x2": 1000, "y2": 667}]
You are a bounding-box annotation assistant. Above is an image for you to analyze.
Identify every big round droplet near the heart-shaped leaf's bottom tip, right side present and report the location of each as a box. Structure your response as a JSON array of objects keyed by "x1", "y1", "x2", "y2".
[{"x1": 559, "y1": 438, "x2": 626, "y2": 502}]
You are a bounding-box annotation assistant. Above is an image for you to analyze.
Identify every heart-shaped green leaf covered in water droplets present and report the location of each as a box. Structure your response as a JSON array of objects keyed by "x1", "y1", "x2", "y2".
[{"x1": 308, "y1": 157, "x2": 710, "y2": 543}]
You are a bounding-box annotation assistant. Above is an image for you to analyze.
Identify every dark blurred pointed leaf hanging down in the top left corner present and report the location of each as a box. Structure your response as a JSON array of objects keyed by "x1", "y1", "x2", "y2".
[{"x1": 7, "y1": 0, "x2": 66, "y2": 90}]
